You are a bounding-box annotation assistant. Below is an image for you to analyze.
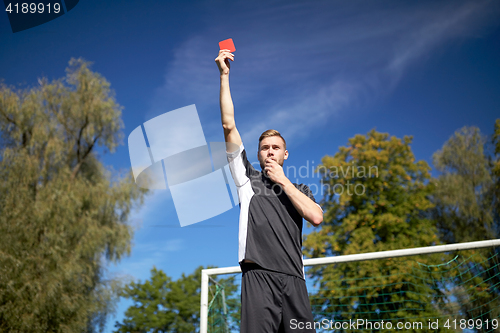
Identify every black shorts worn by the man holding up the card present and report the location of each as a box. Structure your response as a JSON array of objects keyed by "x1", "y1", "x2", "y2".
[{"x1": 240, "y1": 263, "x2": 316, "y2": 333}]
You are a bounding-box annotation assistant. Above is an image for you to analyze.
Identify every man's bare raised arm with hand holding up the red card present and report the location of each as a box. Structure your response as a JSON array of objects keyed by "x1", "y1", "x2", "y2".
[{"x1": 215, "y1": 50, "x2": 241, "y2": 153}]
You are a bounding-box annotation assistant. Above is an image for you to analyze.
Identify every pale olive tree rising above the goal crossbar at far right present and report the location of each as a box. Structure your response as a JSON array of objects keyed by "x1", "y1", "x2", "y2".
[{"x1": 433, "y1": 127, "x2": 495, "y2": 243}]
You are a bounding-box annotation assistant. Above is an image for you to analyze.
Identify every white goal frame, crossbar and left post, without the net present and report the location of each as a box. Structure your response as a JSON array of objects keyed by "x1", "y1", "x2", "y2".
[{"x1": 200, "y1": 239, "x2": 500, "y2": 333}]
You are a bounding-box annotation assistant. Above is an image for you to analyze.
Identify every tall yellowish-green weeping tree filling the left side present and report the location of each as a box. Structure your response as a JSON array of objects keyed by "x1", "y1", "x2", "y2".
[{"x1": 0, "y1": 59, "x2": 145, "y2": 332}]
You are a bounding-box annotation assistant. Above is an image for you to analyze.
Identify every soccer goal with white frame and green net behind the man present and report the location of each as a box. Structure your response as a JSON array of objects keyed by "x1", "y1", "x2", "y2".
[{"x1": 200, "y1": 240, "x2": 500, "y2": 333}]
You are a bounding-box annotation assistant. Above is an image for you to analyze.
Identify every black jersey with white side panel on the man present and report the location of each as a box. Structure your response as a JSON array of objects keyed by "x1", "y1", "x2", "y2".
[{"x1": 227, "y1": 144, "x2": 316, "y2": 279}]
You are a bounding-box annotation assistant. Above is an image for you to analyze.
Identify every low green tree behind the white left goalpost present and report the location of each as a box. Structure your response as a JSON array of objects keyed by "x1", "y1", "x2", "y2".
[{"x1": 115, "y1": 267, "x2": 239, "y2": 333}]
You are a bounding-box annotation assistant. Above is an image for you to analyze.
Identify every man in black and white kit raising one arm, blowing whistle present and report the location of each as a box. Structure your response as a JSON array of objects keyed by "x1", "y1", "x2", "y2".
[{"x1": 215, "y1": 50, "x2": 323, "y2": 333}]
